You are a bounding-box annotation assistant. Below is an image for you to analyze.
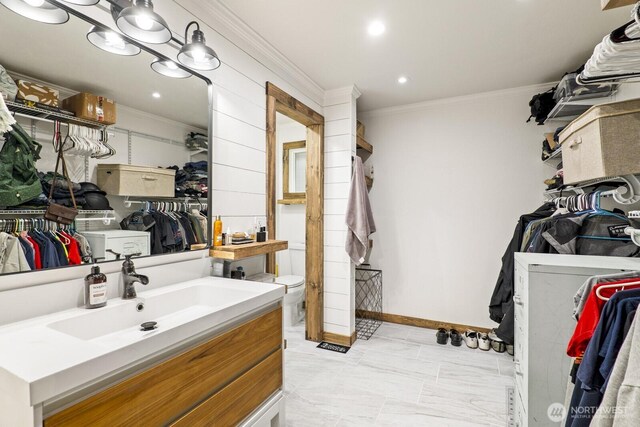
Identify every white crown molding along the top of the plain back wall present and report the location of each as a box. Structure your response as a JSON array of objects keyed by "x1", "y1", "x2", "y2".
[{"x1": 359, "y1": 82, "x2": 558, "y2": 117}]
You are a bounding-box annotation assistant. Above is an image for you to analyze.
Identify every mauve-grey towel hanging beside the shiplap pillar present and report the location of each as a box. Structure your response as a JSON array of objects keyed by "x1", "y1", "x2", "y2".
[{"x1": 345, "y1": 156, "x2": 376, "y2": 265}]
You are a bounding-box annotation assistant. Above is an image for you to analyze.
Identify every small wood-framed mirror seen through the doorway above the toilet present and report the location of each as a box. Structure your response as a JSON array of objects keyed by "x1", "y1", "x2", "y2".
[{"x1": 281, "y1": 141, "x2": 307, "y2": 204}]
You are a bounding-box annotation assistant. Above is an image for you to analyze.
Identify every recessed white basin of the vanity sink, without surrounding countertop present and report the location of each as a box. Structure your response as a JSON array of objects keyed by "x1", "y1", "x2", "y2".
[{"x1": 47, "y1": 281, "x2": 256, "y2": 341}]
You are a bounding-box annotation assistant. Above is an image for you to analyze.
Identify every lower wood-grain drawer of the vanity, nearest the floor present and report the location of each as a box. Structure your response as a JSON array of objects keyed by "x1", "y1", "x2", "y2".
[{"x1": 171, "y1": 350, "x2": 282, "y2": 427}]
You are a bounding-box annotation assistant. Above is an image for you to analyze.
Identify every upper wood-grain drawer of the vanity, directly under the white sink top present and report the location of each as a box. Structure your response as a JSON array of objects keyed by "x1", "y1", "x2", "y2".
[{"x1": 44, "y1": 307, "x2": 282, "y2": 427}]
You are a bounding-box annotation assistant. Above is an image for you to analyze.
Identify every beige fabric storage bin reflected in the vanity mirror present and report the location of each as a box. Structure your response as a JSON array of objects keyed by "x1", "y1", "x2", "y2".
[{"x1": 98, "y1": 164, "x2": 176, "y2": 197}]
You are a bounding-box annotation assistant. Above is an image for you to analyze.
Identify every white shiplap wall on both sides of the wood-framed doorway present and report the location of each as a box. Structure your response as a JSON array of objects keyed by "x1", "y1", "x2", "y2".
[{"x1": 162, "y1": 0, "x2": 357, "y2": 335}]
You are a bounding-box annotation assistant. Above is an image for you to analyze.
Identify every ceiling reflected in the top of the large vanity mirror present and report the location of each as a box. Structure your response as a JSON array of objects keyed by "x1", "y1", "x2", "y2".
[{"x1": 0, "y1": 6, "x2": 208, "y2": 129}]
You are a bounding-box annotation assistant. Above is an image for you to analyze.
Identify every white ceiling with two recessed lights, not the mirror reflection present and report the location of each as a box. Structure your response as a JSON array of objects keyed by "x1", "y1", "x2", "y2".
[{"x1": 218, "y1": 0, "x2": 630, "y2": 111}]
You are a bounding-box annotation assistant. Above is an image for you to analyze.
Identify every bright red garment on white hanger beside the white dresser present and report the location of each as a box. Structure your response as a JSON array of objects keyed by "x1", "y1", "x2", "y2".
[{"x1": 567, "y1": 277, "x2": 640, "y2": 357}]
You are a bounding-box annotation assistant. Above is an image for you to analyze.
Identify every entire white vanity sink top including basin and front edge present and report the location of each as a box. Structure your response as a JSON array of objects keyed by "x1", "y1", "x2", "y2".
[{"x1": 0, "y1": 277, "x2": 284, "y2": 406}]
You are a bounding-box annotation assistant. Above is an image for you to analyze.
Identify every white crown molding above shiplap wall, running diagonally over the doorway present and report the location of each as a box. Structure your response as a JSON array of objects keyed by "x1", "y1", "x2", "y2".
[{"x1": 182, "y1": 0, "x2": 324, "y2": 105}]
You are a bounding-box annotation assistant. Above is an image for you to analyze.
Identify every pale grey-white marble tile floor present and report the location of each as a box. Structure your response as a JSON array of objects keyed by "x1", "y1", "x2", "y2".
[{"x1": 285, "y1": 323, "x2": 514, "y2": 427}]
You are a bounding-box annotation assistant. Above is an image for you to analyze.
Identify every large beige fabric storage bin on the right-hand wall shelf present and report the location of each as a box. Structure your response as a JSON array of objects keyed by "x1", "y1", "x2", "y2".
[{"x1": 560, "y1": 99, "x2": 640, "y2": 184}]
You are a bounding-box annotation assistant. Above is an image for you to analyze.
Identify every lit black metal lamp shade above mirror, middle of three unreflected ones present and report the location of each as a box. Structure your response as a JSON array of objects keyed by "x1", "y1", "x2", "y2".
[{"x1": 116, "y1": 0, "x2": 171, "y2": 44}]
